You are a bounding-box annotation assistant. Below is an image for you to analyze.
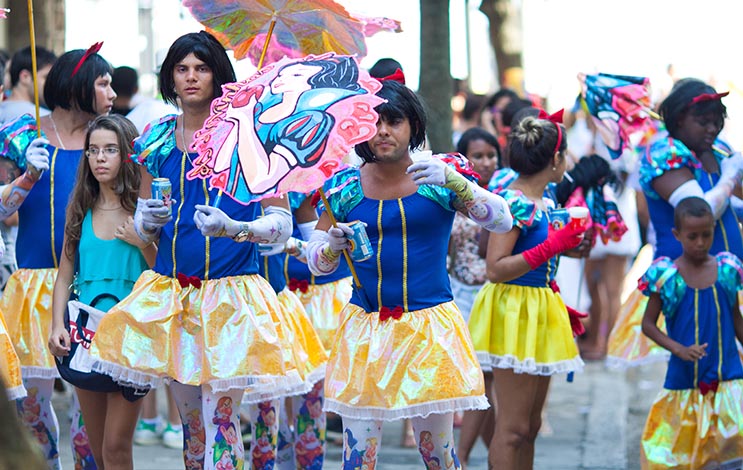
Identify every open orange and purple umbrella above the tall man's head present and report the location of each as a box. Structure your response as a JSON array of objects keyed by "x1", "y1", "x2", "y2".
[{"x1": 183, "y1": 0, "x2": 400, "y2": 68}]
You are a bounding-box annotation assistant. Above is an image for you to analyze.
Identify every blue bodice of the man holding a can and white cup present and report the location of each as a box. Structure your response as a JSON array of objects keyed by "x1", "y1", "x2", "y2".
[{"x1": 320, "y1": 168, "x2": 464, "y2": 311}]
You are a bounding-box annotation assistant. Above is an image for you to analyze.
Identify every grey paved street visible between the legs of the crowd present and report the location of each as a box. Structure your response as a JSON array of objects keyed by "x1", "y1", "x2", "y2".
[{"x1": 55, "y1": 362, "x2": 665, "y2": 470}]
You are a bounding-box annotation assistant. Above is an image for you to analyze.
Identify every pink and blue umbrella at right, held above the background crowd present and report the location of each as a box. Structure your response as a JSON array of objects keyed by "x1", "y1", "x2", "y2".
[{"x1": 578, "y1": 73, "x2": 658, "y2": 158}]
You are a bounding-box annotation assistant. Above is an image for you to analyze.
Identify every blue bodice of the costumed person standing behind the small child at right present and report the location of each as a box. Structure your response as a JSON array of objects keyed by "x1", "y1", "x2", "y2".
[{"x1": 640, "y1": 130, "x2": 743, "y2": 259}]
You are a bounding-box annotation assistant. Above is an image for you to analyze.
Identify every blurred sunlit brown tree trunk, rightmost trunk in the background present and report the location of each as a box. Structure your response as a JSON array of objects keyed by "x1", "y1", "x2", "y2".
[{"x1": 480, "y1": 0, "x2": 523, "y2": 85}]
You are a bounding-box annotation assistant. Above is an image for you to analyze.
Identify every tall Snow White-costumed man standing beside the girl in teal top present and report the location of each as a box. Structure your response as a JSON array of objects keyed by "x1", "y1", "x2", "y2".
[{"x1": 91, "y1": 31, "x2": 305, "y2": 469}]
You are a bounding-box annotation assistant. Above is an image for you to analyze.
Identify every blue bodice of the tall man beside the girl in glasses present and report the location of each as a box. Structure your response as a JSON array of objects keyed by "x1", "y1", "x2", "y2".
[{"x1": 133, "y1": 116, "x2": 261, "y2": 279}]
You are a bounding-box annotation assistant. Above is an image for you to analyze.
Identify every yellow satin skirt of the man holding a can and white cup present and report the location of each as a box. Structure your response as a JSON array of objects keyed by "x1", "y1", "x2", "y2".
[{"x1": 325, "y1": 302, "x2": 488, "y2": 421}]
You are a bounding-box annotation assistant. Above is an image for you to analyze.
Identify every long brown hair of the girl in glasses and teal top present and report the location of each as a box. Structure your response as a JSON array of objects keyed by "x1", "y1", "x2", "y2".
[{"x1": 65, "y1": 114, "x2": 141, "y2": 258}]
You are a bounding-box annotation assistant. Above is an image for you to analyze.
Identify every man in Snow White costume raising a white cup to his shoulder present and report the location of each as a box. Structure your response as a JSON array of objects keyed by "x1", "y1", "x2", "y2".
[{"x1": 307, "y1": 81, "x2": 511, "y2": 468}]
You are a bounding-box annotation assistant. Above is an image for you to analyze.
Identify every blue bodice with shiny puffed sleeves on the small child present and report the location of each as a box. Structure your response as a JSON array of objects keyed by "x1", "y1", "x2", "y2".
[{"x1": 640, "y1": 252, "x2": 743, "y2": 390}]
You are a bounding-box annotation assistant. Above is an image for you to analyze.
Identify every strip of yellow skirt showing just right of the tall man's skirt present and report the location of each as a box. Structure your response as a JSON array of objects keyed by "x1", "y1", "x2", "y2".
[{"x1": 277, "y1": 288, "x2": 328, "y2": 394}]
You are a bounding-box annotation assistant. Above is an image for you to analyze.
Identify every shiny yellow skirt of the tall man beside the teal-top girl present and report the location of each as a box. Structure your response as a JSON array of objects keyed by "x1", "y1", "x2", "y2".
[{"x1": 90, "y1": 271, "x2": 303, "y2": 399}]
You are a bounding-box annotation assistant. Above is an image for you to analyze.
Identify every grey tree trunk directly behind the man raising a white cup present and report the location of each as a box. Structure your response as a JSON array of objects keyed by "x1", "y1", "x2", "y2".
[{"x1": 418, "y1": 0, "x2": 454, "y2": 152}]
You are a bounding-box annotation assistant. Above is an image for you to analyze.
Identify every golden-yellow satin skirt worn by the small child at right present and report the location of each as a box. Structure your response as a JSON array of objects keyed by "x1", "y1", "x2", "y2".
[{"x1": 640, "y1": 380, "x2": 743, "y2": 470}]
